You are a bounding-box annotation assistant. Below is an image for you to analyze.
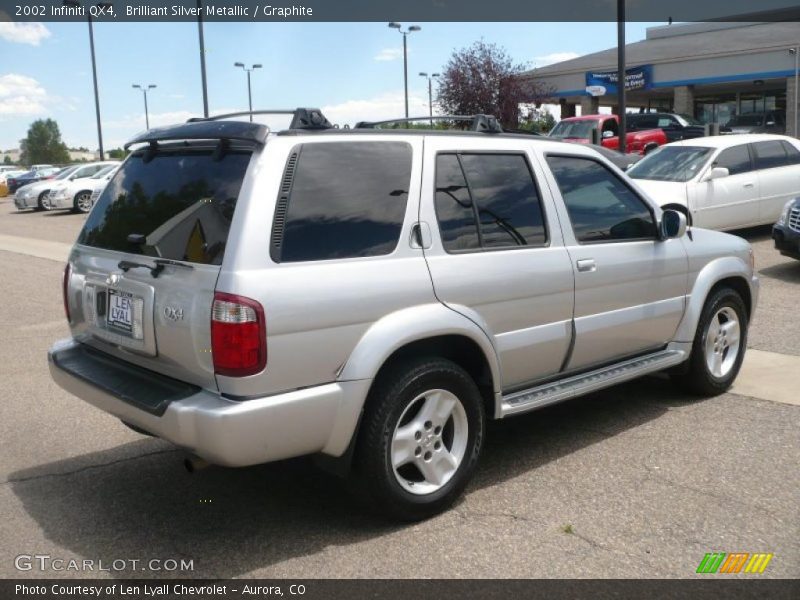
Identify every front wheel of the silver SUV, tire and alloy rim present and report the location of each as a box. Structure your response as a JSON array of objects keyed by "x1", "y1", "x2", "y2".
[{"x1": 672, "y1": 287, "x2": 748, "y2": 396}]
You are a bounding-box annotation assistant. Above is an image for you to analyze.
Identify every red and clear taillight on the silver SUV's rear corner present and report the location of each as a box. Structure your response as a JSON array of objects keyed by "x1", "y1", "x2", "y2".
[{"x1": 211, "y1": 292, "x2": 267, "y2": 377}]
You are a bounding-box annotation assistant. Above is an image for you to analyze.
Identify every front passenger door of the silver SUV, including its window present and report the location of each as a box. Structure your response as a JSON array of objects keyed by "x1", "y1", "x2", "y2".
[{"x1": 547, "y1": 155, "x2": 688, "y2": 371}]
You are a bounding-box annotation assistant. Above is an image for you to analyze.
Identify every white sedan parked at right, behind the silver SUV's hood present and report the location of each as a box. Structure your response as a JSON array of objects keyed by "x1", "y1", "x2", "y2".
[{"x1": 628, "y1": 134, "x2": 800, "y2": 231}]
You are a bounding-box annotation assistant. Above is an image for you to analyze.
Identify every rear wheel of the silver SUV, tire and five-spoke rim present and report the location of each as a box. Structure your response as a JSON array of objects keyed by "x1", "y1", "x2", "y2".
[{"x1": 356, "y1": 358, "x2": 485, "y2": 521}]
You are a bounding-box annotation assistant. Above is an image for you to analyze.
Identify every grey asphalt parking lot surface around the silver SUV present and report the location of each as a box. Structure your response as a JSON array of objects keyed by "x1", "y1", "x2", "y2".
[{"x1": 0, "y1": 198, "x2": 800, "y2": 578}]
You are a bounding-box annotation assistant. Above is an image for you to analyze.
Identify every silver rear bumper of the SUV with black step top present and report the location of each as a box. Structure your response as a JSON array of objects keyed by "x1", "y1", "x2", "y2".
[{"x1": 48, "y1": 339, "x2": 369, "y2": 467}]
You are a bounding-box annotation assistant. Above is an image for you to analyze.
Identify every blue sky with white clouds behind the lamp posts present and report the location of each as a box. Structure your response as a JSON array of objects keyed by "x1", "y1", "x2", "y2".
[{"x1": 0, "y1": 22, "x2": 654, "y2": 150}]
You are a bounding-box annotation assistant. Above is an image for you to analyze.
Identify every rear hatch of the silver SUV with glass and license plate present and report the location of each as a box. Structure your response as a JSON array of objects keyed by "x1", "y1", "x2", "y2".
[{"x1": 67, "y1": 140, "x2": 253, "y2": 389}]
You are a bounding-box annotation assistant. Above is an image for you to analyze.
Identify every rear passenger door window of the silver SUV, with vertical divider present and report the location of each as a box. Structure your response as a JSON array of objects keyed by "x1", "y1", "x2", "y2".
[{"x1": 435, "y1": 153, "x2": 547, "y2": 252}]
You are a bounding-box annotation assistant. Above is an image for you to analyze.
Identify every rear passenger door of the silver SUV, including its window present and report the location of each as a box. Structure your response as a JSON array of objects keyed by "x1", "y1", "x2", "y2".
[{"x1": 420, "y1": 136, "x2": 574, "y2": 390}]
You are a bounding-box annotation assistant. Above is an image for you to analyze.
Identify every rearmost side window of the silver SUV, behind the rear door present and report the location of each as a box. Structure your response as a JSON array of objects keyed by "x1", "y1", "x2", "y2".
[{"x1": 272, "y1": 142, "x2": 411, "y2": 262}]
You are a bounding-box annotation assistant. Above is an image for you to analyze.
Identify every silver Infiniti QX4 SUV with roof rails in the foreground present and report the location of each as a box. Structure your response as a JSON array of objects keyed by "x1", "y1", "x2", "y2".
[{"x1": 49, "y1": 109, "x2": 758, "y2": 519}]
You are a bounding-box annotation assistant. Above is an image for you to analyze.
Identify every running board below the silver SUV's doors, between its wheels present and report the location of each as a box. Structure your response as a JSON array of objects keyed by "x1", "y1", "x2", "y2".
[{"x1": 500, "y1": 349, "x2": 688, "y2": 417}]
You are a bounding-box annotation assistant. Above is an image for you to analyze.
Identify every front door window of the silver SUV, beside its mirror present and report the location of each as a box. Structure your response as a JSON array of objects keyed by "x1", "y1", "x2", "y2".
[{"x1": 547, "y1": 156, "x2": 656, "y2": 244}]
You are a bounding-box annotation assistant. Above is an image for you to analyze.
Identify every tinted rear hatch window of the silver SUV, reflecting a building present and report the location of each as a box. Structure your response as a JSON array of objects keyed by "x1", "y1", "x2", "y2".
[{"x1": 78, "y1": 149, "x2": 250, "y2": 265}]
